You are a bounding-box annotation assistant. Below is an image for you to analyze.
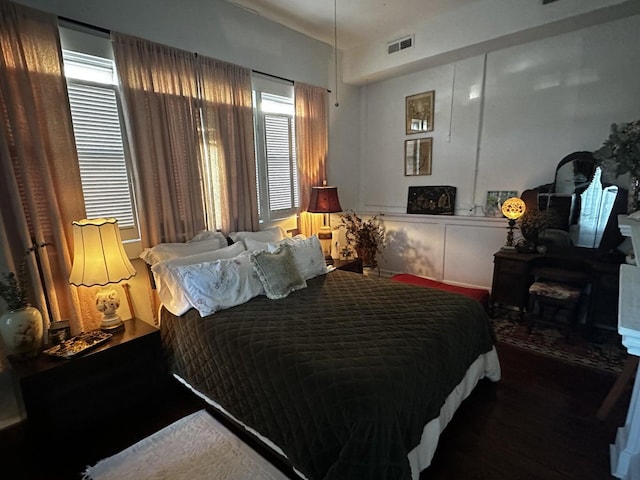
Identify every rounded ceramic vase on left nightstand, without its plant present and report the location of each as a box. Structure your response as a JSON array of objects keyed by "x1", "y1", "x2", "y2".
[{"x1": 0, "y1": 305, "x2": 44, "y2": 358}]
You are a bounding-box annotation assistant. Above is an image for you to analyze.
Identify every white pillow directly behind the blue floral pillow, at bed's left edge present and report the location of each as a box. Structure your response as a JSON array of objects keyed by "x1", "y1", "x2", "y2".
[{"x1": 151, "y1": 243, "x2": 244, "y2": 316}]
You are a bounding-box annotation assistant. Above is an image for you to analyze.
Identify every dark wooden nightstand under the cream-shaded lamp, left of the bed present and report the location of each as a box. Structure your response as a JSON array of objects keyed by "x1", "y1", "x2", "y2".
[{"x1": 10, "y1": 318, "x2": 169, "y2": 435}]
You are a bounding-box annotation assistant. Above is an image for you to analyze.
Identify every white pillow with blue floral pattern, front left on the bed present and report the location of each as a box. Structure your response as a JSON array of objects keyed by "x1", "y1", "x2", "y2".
[{"x1": 171, "y1": 252, "x2": 264, "y2": 317}]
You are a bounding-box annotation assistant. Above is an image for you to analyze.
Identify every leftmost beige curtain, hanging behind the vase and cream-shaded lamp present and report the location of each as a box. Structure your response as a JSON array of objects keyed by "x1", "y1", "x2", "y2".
[{"x1": 0, "y1": 1, "x2": 86, "y2": 333}]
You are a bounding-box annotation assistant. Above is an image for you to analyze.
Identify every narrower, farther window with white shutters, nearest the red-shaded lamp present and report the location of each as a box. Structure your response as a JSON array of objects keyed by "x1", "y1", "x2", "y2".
[{"x1": 253, "y1": 77, "x2": 299, "y2": 223}]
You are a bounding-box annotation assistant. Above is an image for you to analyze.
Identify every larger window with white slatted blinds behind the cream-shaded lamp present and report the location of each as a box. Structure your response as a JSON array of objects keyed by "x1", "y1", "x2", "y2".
[{"x1": 61, "y1": 28, "x2": 139, "y2": 241}]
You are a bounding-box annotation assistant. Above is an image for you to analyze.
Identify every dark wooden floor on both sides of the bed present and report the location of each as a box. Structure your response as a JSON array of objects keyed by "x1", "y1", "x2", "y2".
[{"x1": 0, "y1": 345, "x2": 630, "y2": 480}]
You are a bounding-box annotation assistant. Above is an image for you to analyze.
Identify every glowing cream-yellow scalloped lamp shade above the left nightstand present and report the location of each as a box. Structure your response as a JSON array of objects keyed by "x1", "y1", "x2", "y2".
[{"x1": 69, "y1": 218, "x2": 136, "y2": 287}]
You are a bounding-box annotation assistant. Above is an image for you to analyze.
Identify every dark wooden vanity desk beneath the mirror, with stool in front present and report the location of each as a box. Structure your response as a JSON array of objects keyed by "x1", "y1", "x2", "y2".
[{"x1": 491, "y1": 248, "x2": 622, "y2": 329}]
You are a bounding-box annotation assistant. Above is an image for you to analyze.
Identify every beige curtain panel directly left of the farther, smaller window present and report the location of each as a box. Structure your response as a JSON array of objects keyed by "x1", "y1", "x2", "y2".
[{"x1": 198, "y1": 57, "x2": 258, "y2": 232}]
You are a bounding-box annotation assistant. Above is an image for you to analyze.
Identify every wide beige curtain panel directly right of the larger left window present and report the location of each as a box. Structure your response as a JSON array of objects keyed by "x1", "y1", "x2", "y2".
[{"x1": 112, "y1": 33, "x2": 205, "y2": 246}]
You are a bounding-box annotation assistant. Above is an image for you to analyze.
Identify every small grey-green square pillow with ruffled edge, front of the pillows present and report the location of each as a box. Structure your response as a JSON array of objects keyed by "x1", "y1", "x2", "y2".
[{"x1": 251, "y1": 244, "x2": 307, "y2": 300}]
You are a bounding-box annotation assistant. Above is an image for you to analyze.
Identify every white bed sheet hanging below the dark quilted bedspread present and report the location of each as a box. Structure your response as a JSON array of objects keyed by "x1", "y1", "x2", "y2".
[{"x1": 173, "y1": 347, "x2": 501, "y2": 480}]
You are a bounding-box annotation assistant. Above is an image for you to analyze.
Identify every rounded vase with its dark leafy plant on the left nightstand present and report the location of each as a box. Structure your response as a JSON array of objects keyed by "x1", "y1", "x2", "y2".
[{"x1": 0, "y1": 265, "x2": 44, "y2": 358}]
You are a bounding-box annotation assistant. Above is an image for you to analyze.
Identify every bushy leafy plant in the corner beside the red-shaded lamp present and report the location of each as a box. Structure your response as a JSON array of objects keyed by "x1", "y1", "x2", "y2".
[{"x1": 340, "y1": 210, "x2": 385, "y2": 268}]
